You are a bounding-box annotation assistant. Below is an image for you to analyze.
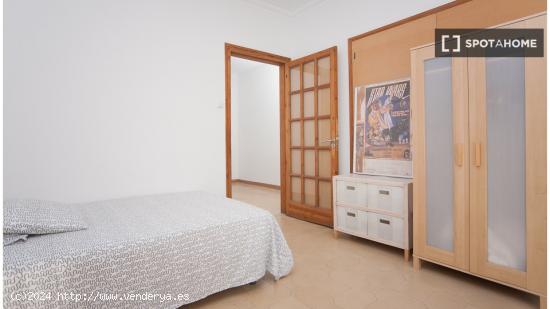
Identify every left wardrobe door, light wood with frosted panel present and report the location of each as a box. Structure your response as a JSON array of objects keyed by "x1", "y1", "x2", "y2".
[{"x1": 411, "y1": 45, "x2": 469, "y2": 270}]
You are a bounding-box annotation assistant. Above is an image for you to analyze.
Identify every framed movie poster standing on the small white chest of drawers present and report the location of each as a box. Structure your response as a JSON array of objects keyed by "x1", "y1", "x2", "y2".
[{"x1": 353, "y1": 79, "x2": 412, "y2": 178}]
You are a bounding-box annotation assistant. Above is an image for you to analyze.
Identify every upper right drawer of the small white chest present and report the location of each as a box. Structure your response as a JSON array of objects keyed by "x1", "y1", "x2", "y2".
[{"x1": 367, "y1": 184, "x2": 404, "y2": 214}]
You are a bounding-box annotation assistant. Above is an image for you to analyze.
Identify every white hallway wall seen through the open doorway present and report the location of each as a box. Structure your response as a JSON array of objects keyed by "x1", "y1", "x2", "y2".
[{"x1": 231, "y1": 60, "x2": 280, "y2": 186}]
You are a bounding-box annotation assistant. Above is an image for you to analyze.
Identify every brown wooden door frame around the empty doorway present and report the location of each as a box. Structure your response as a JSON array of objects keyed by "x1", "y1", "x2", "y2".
[{"x1": 225, "y1": 43, "x2": 290, "y2": 213}]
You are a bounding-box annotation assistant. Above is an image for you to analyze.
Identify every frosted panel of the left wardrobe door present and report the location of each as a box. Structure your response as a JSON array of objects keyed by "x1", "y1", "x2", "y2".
[{"x1": 424, "y1": 58, "x2": 454, "y2": 251}]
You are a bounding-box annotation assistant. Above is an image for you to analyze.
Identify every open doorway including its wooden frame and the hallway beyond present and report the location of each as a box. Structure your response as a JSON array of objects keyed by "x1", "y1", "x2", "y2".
[{"x1": 225, "y1": 44, "x2": 290, "y2": 214}]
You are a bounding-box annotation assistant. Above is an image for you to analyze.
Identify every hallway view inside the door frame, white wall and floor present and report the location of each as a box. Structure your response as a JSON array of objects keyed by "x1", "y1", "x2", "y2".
[{"x1": 231, "y1": 57, "x2": 281, "y2": 214}]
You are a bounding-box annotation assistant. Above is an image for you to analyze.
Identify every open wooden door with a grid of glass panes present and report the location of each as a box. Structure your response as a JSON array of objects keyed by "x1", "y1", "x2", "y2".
[{"x1": 285, "y1": 47, "x2": 338, "y2": 226}]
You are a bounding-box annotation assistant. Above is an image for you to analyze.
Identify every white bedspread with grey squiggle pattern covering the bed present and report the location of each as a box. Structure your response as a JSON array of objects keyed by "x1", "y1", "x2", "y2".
[{"x1": 4, "y1": 192, "x2": 293, "y2": 308}]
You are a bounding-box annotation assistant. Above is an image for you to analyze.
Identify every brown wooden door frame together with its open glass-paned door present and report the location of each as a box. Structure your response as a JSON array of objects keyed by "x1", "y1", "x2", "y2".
[{"x1": 225, "y1": 43, "x2": 338, "y2": 226}]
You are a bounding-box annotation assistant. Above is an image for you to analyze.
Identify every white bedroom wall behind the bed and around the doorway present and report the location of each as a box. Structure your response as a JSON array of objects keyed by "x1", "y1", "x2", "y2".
[{"x1": 4, "y1": 0, "x2": 446, "y2": 201}]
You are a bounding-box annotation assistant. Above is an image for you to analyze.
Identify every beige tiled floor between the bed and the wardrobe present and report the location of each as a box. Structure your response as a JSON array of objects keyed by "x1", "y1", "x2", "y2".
[{"x1": 190, "y1": 184, "x2": 538, "y2": 309}]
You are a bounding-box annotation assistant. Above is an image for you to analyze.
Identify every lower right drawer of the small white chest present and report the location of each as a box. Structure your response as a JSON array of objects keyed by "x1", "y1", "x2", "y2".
[{"x1": 367, "y1": 212, "x2": 404, "y2": 248}]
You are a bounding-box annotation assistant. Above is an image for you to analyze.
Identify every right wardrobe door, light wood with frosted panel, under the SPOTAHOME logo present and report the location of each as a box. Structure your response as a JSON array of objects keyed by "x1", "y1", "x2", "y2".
[{"x1": 468, "y1": 16, "x2": 546, "y2": 293}]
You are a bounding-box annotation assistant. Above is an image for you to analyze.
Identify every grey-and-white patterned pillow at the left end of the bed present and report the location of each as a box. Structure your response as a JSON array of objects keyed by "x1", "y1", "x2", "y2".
[{"x1": 4, "y1": 200, "x2": 87, "y2": 234}]
